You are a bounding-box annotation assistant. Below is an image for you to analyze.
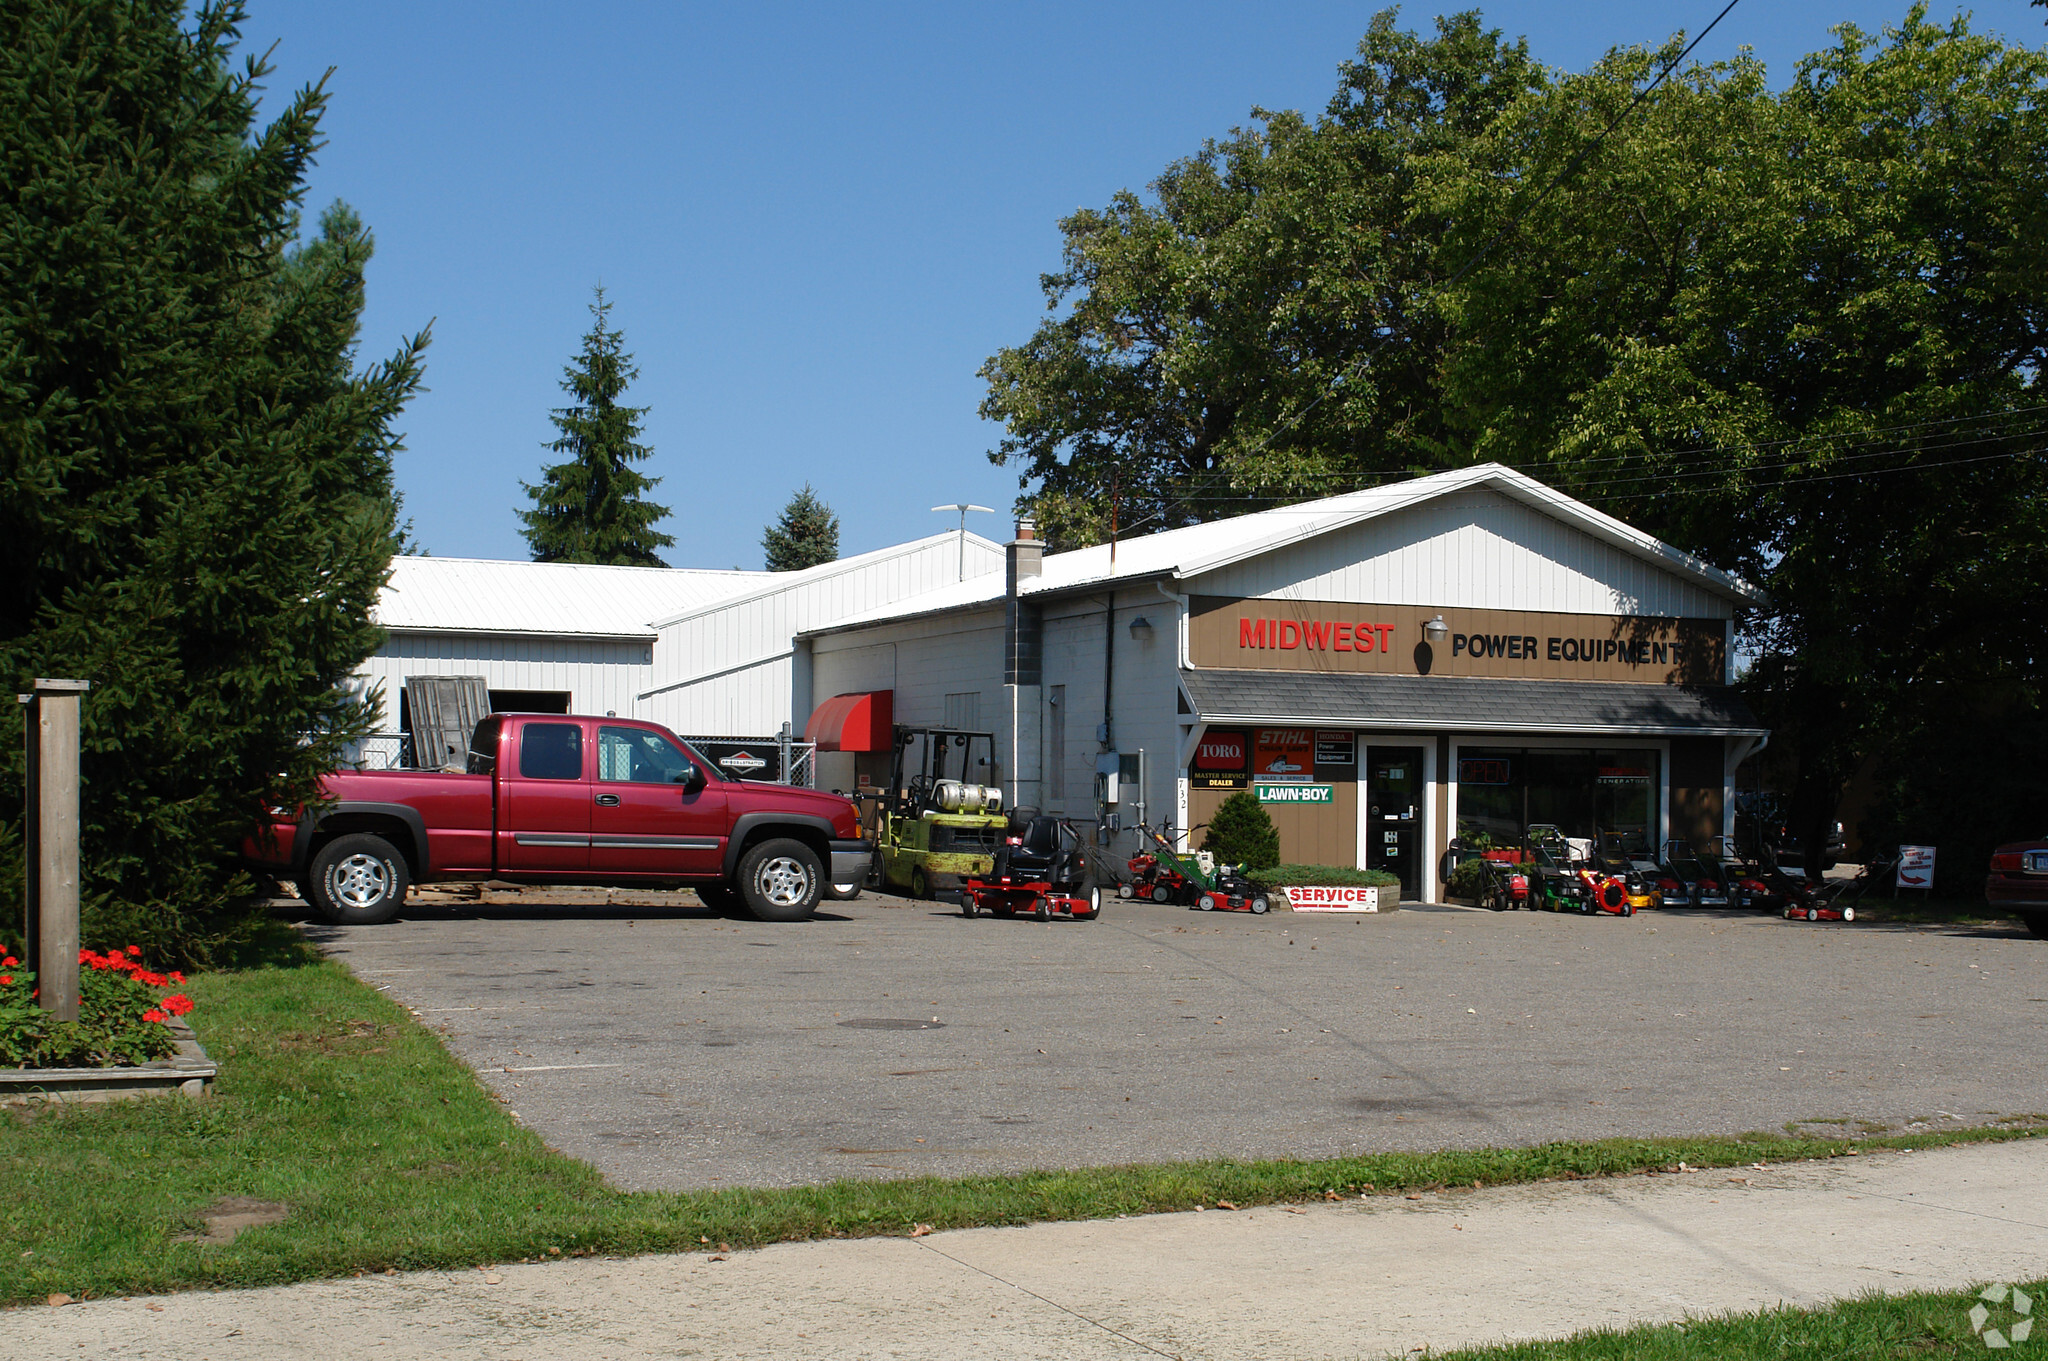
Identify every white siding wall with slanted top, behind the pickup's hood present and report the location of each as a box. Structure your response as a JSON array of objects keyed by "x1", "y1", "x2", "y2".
[{"x1": 643, "y1": 538, "x2": 1004, "y2": 735}]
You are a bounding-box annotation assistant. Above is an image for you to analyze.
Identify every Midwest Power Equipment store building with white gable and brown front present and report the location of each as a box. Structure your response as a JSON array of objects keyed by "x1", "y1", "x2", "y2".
[{"x1": 793, "y1": 465, "x2": 1763, "y2": 896}]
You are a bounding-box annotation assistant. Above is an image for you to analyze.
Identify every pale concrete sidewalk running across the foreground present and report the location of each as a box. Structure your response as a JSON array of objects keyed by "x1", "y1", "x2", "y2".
[{"x1": 0, "y1": 1140, "x2": 2048, "y2": 1361}]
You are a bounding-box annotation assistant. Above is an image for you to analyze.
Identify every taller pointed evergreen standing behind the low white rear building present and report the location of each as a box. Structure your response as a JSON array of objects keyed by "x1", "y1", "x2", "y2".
[{"x1": 518, "y1": 284, "x2": 676, "y2": 567}]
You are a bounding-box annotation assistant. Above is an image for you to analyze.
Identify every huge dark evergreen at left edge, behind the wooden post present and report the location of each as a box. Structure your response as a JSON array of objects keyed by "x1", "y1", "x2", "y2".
[{"x1": 0, "y1": 0, "x2": 426, "y2": 960}]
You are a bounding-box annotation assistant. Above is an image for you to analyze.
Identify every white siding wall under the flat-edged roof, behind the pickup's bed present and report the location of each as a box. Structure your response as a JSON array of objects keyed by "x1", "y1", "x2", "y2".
[{"x1": 356, "y1": 632, "x2": 653, "y2": 733}]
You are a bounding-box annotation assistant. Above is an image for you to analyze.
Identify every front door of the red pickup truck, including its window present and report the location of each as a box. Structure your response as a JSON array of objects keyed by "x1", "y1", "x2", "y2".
[{"x1": 590, "y1": 722, "x2": 727, "y2": 878}]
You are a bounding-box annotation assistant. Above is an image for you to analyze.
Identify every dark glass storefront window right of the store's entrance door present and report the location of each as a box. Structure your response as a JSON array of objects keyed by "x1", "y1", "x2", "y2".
[{"x1": 1456, "y1": 747, "x2": 1663, "y2": 845}]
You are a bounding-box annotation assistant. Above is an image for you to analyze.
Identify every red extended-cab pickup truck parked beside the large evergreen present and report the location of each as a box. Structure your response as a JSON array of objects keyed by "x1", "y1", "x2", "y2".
[{"x1": 242, "y1": 714, "x2": 874, "y2": 925}]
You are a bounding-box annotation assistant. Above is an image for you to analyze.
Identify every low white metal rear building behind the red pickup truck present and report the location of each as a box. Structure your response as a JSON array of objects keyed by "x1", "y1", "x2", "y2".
[{"x1": 354, "y1": 530, "x2": 1004, "y2": 763}]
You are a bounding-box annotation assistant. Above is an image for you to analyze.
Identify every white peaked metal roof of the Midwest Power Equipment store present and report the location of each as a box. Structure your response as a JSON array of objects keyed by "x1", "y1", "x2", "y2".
[{"x1": 798, "y1": 463, "x2": 1763, "y2": 628}]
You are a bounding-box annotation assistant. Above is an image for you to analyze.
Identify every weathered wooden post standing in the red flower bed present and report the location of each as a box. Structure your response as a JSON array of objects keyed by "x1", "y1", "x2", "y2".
[{"x1": 18, "y1": 679, "x2": 92, "y2": 1021}]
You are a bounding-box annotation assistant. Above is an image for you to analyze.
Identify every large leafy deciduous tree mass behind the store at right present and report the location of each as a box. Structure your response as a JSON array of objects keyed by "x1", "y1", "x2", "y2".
[{"x1": 983, "y1": 6, "x2": 2048, "y2": 871}]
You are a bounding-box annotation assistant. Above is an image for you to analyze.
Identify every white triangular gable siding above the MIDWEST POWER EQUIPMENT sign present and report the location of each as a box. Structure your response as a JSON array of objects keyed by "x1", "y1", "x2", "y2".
[{"x1": 1186, "y1": 491, "x2": 1733, "y2": 618}]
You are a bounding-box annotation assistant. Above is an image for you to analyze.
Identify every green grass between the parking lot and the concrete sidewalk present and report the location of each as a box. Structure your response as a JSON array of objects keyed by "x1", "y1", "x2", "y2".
[{"x1": 0, "y1": 935, "x2": 2036, "y2": 1301}]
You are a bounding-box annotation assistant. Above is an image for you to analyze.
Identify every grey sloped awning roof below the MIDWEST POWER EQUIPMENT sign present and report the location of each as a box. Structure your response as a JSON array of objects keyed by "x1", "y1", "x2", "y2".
[{"x1": 1180, "y1": 669, "x2": 1765, "y2": 737}]
